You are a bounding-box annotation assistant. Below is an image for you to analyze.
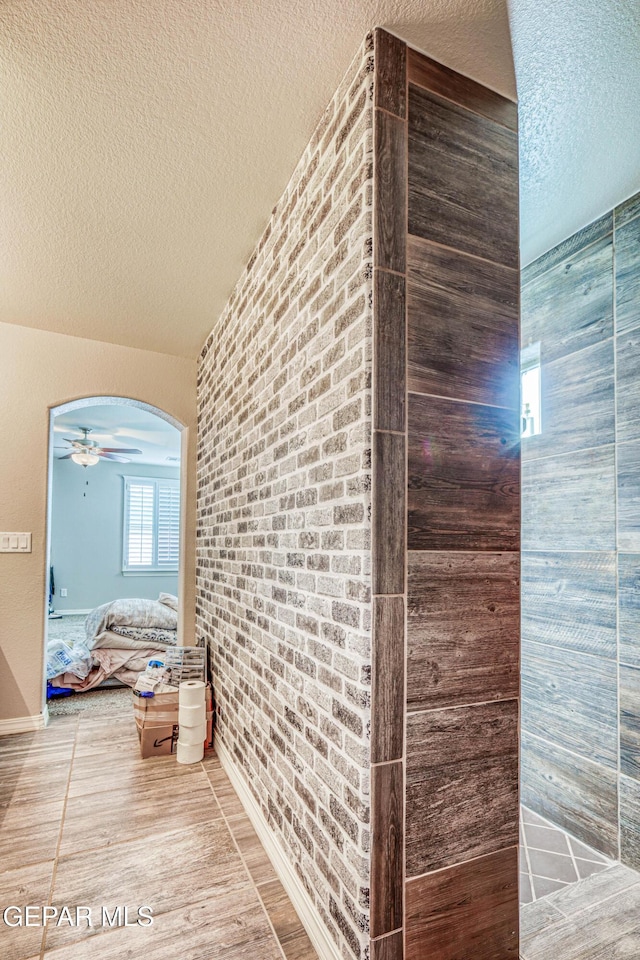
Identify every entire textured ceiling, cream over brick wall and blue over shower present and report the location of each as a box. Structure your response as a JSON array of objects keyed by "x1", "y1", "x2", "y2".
[{"x1": 0, "y1": 0, "x2": 640, "y2": 356}]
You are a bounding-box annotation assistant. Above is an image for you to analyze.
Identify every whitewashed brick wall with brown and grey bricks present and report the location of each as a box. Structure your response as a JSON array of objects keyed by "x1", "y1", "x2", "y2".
[{"x1": 197, "y1": 38, "x2": 373, "y2": 957}]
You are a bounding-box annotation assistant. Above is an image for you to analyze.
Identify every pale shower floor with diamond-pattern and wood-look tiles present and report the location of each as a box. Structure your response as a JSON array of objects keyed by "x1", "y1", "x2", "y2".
[{"x1": 520, "y1": 809, "x2": 640, "y2": 960}]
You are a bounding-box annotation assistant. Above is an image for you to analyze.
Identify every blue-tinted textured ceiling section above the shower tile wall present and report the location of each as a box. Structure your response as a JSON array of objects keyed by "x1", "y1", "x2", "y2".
[{"x1": 509, "y1": 0, "x2": 640, "y2": 264}]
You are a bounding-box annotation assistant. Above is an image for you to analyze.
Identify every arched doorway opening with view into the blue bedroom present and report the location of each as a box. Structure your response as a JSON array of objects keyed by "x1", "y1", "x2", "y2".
[{"x1": 43, "y1": 397, "x2": 184, "y2": 719}]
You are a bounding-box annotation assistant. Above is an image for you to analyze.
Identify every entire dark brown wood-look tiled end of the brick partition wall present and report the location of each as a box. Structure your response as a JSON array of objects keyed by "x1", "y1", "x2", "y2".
[{"x1": 371, "y1": 30, "x2": 520, "y2": 960}]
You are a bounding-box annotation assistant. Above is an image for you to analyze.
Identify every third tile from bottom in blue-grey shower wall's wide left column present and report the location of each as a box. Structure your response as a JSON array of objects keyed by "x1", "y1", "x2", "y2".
[{"x1": 522, "y1": 551, "x2": 616, "y2": 659}]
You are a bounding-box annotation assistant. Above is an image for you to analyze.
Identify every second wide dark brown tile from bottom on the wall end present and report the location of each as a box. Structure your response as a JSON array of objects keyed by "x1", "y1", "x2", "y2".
[{"x1": 405, "y1": 700, "x2": 519, "y2": 877}]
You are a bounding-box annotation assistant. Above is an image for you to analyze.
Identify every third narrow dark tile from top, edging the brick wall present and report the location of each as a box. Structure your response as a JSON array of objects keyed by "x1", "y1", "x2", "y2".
[{"x1": 373, "y1": 270, "x2": 406, "y2": 431}]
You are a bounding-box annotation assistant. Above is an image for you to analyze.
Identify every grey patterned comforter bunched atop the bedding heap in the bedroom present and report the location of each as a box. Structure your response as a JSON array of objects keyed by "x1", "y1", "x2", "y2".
[{"x1": 85, "y1": 593, "x2": 178, "y2": 650}]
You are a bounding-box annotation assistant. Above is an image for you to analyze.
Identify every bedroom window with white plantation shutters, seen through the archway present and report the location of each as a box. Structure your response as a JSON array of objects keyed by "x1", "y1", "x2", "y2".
[{"x1": 122, "y1": 477, "x2": 180, "y2": 573}]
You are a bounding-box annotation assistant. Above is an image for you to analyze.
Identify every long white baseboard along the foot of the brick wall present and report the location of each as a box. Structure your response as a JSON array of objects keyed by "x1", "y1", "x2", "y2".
[{"x1": 215, "y1": 740, "x2": 341, "y2": 960}]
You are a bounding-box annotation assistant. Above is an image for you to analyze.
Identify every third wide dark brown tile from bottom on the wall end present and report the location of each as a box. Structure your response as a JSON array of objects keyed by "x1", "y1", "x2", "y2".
[{"x1": 407, "y1": 551, "x2": 520, "y2": 711}]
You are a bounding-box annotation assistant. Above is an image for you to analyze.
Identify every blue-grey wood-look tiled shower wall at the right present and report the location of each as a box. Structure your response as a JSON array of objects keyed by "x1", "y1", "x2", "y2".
[{"x1": 522, "y1": 195, "x2": 640, "y2": 868}]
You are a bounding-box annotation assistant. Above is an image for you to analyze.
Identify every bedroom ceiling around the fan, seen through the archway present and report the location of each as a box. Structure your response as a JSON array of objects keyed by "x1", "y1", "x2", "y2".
[{"x1": 53, "y1": 404, "x2": 180, "y2": 468}]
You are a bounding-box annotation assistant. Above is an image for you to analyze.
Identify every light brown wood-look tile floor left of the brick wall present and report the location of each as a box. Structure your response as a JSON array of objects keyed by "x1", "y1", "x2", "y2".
[{"x1": 0, "y1": 711, "x2": 317, "y2": 960}]
